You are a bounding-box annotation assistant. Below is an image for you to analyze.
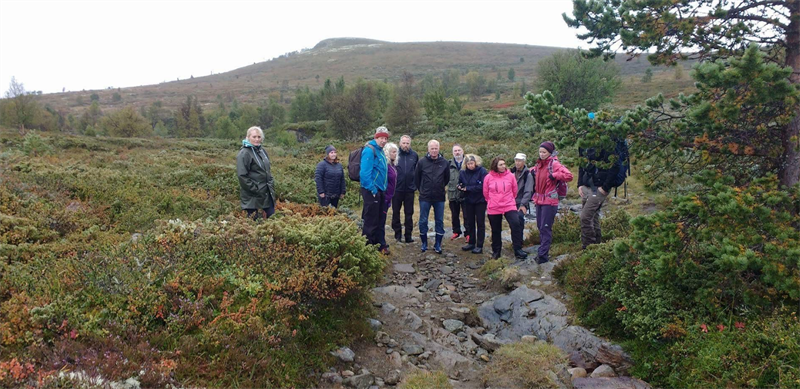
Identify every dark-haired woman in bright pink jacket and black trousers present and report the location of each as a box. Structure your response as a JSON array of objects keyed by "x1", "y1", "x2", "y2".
[{"x1": 483, "y1": 157, "x2": 528, "y2": 259}]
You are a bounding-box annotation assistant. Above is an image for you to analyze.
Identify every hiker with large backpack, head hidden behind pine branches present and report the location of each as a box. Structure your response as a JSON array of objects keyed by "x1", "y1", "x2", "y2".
[{"x1": 578, "y1": 149, "x2": 619, "y2": 248}]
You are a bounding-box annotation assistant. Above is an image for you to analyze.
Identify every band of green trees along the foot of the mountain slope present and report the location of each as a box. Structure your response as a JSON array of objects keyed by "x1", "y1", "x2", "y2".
[{"x1": 0, "y1": 55, "x2": 620, "y2": 146}]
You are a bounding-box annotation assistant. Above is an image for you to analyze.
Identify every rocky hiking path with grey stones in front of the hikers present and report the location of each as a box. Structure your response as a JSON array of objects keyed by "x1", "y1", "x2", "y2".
[{"x1": 319, "y1": 227, "x2": 650, "y2": 389}]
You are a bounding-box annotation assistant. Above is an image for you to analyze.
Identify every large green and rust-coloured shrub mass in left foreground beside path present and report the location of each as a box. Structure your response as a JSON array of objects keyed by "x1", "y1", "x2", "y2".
[{"x1": 0, "y1": 192, "x2": 384, "y2": 388}]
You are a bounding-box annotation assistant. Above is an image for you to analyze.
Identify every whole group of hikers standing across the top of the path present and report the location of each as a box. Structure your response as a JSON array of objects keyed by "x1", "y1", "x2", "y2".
[{"x1": 236, "y1": 126, "x2": 618, "y2": 264}]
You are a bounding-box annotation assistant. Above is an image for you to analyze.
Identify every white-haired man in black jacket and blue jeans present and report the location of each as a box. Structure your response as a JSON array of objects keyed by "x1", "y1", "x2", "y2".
[{"x1": 414, "y1": 139, "x2": 450, "y2": 254}]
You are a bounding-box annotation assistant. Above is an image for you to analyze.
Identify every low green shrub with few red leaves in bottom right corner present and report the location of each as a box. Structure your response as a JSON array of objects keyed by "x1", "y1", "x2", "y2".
[{"x1": 631, "y1": 309, "x2": 800, "y2": 389}]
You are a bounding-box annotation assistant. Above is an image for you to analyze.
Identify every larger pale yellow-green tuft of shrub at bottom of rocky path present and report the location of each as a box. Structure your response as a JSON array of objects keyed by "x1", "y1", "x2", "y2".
[{"x1": 483, "y1": 342, "x2": 567, "y2": 389}]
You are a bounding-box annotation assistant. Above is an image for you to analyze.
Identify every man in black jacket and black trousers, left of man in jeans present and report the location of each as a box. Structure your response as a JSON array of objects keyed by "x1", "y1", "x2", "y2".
[{"x1": 392, "y1": 135, "x2": 419, "y2": 243}]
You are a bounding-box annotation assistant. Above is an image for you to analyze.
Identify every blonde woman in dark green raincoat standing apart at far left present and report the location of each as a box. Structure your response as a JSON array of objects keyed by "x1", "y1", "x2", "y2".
[{"x1": 236, "y1": 126, "x2": 275, "y2": 220}]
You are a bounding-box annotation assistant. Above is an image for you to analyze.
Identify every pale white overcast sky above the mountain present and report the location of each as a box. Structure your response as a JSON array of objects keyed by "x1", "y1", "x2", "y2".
[{"x1": 0, "y1": 0, "x2": 588, "y2": 93}]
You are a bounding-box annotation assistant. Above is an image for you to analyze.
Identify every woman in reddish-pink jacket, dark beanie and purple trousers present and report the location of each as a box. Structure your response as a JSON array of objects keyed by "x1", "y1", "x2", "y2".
[{"x1": 531, "y1": 141, "x2": 572, "y2": 264}]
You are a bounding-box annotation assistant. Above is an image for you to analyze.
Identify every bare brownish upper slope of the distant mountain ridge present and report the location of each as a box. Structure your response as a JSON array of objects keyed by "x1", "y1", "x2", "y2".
[{"x1": 34, "y1": 38, "x2": 649, "y2": 112}]
